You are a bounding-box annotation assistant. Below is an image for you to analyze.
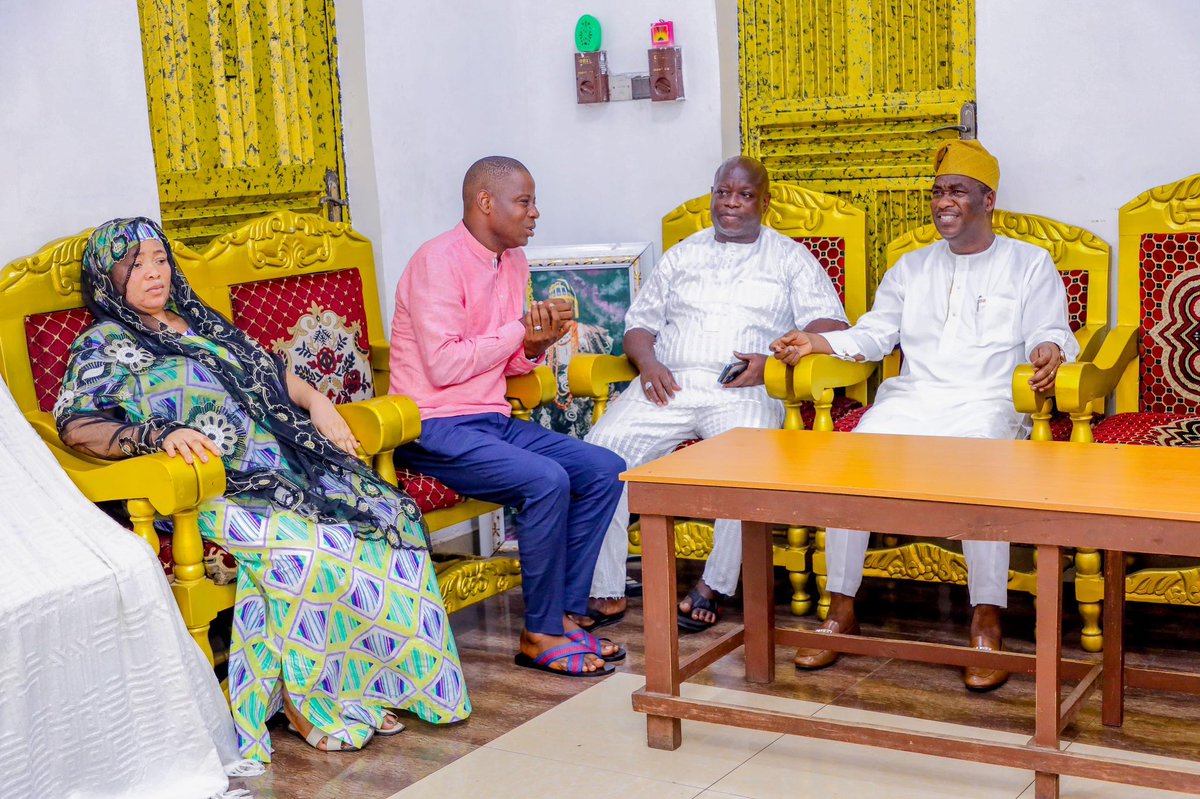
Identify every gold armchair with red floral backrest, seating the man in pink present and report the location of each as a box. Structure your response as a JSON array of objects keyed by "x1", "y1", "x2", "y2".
[{"x1": 196, "y1": 211, "x2": 553, "y2": 612}]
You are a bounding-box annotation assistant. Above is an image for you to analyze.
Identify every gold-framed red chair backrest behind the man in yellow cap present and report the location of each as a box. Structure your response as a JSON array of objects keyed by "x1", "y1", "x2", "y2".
[{"x1": 887, "y1": 209, "x2": 1111, "y2": 360}]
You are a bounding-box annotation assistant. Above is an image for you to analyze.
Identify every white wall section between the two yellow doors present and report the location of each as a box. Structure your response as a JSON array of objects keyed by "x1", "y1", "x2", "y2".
[{"x1": 337, "y1": 0, "x2": 722, "y2": 312}]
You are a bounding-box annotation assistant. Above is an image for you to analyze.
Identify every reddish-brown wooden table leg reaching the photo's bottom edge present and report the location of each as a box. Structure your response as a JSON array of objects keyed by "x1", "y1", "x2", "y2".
[{"x1": 1033, "y1": 543, "x2": 1062, "y2": 799}]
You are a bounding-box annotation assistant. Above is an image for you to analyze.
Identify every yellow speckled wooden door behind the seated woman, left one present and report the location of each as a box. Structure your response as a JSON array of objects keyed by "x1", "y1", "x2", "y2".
[{"x1": 138, "y1": 0, "x2": 349, "y2": 246}]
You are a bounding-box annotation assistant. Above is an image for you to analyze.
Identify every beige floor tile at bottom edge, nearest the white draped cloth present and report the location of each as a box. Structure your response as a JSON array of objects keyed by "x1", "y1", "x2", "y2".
[{"x1": 390, "y1": 746, "x2": 700, "y2": 799}]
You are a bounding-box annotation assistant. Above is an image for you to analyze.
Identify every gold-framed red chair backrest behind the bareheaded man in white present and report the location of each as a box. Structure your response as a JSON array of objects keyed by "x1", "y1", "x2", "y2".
[{"x1": 662, "y1": 181, "x2": 866, "y2": 323}]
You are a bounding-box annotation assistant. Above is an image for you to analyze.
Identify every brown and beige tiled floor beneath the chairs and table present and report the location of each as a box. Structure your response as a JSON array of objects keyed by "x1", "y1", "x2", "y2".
[{"x1": 234, "y1": 559, "x2": 1200, "y2": 799}]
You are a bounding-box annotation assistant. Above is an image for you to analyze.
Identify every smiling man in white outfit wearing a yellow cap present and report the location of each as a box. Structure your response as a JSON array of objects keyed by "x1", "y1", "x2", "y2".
[{"x1": 772, "y1": 140, "x2": 1079, "y2": 691}]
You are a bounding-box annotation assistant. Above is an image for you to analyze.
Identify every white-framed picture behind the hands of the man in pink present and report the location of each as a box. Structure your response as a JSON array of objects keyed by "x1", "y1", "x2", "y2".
[{"x1": 526, "y1": 241, "x2": 650, "y2": 438}]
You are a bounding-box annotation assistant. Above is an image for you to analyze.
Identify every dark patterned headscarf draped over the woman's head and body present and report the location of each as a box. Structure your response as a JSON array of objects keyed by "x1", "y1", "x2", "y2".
[{"x1": 77, "y1": 217, "x2": 430, "y2": 548}]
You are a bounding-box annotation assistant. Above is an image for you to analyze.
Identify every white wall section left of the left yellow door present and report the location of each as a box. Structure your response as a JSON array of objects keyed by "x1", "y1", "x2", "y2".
[{"x1": 0, "y1": 0, "x2": 158, "y2": 265}]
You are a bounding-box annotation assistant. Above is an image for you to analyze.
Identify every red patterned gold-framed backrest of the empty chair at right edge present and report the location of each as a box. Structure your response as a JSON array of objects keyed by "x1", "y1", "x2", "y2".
[{"x1": 1116, "y1": 174, "x2": 1200, "y2": 414}]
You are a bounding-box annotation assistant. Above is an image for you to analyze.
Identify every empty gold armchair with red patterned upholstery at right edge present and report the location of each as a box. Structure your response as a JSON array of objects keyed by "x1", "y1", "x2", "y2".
[{"x1": 1055, "y1": 174, "x2": 1200, "y2": 651}]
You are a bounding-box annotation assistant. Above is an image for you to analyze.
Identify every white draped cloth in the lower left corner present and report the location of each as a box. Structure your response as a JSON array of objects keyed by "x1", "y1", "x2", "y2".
[{"x1": 0, "y1": 384, "x2": 245, "y2": 799}]
